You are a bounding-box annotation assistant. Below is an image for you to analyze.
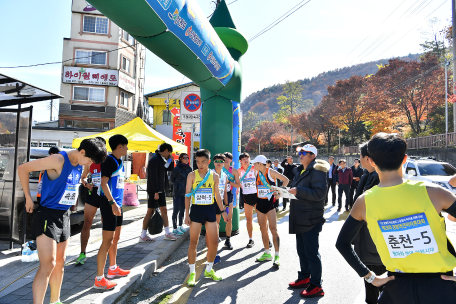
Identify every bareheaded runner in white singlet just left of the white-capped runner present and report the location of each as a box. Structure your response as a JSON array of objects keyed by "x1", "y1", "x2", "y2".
[{"x1": 238, "y1": 152, "x2": 257, "y2": 248}]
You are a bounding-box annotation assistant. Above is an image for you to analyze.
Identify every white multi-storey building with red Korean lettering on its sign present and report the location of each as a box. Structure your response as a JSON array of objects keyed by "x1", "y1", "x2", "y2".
[{"x1": 58, "y1": 0, "x2": 148, "y2": 130}]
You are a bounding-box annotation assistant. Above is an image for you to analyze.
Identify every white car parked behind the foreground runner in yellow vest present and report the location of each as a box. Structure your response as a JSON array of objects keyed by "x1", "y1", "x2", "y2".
[{"x1": 403, "y1": 157, "x2": 456, "y2": 194}]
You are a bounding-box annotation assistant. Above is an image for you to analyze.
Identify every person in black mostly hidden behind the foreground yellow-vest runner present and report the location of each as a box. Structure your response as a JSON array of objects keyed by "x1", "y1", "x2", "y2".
[{"x1": 353, "y1": 143, "x2": 386, "y2": 304}]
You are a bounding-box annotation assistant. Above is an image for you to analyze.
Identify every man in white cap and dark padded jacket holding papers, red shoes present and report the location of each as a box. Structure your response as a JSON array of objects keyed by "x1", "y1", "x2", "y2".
[{"x1": 289, "y1": 145, "x2": 329, "y2": 298}]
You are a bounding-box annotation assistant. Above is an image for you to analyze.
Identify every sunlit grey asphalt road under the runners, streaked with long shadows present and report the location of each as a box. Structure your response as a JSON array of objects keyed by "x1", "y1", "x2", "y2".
[{"x1": 127, "y1": 200, "x2": 364, "y2": 304}]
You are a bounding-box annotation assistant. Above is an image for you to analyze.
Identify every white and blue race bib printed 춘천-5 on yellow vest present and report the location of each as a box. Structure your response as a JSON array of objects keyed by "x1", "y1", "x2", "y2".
[{"x1": 378, "y1": 212, "x2": 439, "y2": 259}]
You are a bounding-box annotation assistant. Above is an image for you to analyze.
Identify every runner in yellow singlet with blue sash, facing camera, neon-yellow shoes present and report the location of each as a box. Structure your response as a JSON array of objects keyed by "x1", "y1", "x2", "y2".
[{"x1": 185, "y1": 149, "x2": 229, "y2": 286}]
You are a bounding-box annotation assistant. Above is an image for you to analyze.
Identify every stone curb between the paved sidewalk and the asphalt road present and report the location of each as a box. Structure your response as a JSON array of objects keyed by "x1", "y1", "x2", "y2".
[{"x1": 92, "y1": 230, "x2": 190, "y2": 304}]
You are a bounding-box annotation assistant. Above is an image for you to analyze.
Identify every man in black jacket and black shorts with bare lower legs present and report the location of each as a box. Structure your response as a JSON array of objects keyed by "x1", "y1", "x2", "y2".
[{"x1": 139, "y1": 143, "x2": 177, "y2": 242}]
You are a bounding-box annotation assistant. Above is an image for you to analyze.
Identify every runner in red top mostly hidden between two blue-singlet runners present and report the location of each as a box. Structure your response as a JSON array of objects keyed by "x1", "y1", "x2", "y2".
[{"x1": 75, "y1": 137, "x2": 106, "y2": 266}]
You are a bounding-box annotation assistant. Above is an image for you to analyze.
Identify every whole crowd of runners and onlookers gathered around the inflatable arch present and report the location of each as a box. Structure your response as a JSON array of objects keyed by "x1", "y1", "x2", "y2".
[{"x1": 18, "y1": 133, "x2": 456, "y2": 304}]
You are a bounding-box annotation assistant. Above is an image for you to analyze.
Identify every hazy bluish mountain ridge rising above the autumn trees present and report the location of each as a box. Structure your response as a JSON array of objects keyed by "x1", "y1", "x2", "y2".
[{"x1": 241, "y1": 54, "x2": 421, "y2": 115}]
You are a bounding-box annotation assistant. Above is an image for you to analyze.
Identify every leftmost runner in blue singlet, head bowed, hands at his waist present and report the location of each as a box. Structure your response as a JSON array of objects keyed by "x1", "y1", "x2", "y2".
[{"x1": 18, "y1": 138, "x2": 106, "y2": 303}]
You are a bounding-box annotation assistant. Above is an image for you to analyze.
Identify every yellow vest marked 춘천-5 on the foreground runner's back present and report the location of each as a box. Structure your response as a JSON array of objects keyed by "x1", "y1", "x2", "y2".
[{"x1": 365, "y1": 180, "x2": 456, "y2": 273}]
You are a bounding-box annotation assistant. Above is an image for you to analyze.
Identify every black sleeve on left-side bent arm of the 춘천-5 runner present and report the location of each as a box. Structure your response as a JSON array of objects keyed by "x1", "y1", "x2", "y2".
[{"x1": 336, "y1": 215, "x2": 369, "y2": 277}]
